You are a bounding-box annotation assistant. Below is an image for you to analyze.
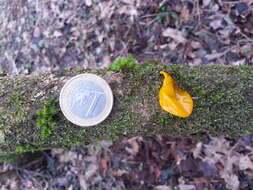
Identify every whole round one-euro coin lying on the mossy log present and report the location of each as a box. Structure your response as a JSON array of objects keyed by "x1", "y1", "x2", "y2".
[{"x1": 60, "y1": 74, "x2": 113, "y2": 127}]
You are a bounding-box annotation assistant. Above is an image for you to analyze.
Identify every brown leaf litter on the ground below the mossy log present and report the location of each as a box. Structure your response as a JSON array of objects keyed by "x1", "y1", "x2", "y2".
[{"x1": 0, "y1": 135, "x2": 253, "y2": 190}]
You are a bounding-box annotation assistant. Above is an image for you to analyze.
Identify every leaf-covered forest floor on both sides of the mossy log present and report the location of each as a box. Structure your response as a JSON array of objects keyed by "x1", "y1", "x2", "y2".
[{"x1": 0, "y1": 0, "x2": 253, "y2": 190}]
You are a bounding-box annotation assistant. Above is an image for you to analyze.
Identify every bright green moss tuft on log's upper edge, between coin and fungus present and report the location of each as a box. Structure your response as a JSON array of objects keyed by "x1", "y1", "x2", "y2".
[{"x1": 108, "y1": 55, "x2": 139, "y2": 71}]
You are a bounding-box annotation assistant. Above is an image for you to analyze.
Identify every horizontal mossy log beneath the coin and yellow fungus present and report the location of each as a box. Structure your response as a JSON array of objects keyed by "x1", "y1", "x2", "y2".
[{"x1": 0, "y1": 64, "x2": 253, "y2": 154}]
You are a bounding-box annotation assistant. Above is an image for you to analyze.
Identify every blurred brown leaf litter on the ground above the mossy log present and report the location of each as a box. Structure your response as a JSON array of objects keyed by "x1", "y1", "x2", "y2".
[{"x1": 0, "y1": 0, "x2": 253, "y2": 74}]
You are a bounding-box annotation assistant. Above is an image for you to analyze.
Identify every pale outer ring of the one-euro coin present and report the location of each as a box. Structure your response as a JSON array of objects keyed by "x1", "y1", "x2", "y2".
[{"x1": 59, "y1": 73, "x2": 113, "y2": 127}]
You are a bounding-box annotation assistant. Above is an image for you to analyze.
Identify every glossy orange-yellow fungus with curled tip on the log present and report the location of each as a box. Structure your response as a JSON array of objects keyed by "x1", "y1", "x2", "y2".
[{"x1": 159, "y1": 71, "x2": 193, "y2": 117}]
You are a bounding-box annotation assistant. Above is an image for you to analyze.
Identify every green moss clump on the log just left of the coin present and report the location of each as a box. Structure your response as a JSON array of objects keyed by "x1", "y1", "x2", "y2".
[{"x1": 35, "y1": 99, "x2": 59, "y2": 138}]
